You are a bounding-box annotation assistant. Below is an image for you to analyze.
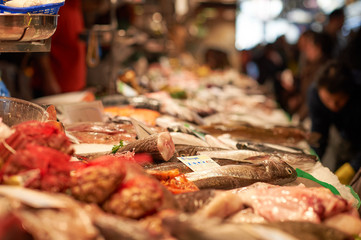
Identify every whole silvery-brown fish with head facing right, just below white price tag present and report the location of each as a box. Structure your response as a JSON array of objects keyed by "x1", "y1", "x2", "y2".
[{"x1": 185, "y1": 159, "x2": 297, "y2": 189}]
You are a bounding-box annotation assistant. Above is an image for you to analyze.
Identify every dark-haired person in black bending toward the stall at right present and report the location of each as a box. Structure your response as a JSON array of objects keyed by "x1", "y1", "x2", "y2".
[{"x1": 307, "y1": 60, "x2": 361, "y2": 184}]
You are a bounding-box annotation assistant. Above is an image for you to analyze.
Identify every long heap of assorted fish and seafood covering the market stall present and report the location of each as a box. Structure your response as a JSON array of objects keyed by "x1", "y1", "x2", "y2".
[{"x1": 0, "y1": 65, "x2": 361, "y2": 240}]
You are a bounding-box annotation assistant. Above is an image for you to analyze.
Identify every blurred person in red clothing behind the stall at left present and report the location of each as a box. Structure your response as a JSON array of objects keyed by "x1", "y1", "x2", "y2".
[{"x1": 33, "y1": 0, "x2": 86, "y2": 97}]
